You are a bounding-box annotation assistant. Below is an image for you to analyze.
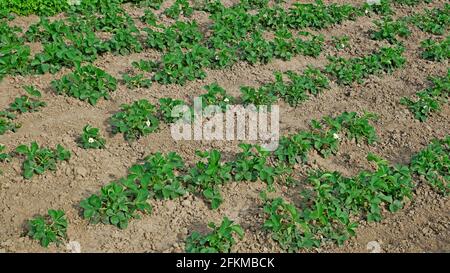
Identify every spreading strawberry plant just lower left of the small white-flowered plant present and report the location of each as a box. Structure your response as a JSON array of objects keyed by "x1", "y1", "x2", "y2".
[{"x1": 16, "y1": 142, "x2": 70, "y2": 179}]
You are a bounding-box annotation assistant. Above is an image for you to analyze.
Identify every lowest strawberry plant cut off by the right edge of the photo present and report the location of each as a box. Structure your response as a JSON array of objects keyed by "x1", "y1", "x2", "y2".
[{"x1": 411, "y1": 135, "x2": 450, "y2": 195}]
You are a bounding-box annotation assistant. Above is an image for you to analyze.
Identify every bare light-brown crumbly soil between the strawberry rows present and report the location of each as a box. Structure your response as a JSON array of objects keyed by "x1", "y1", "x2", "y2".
[{"x1": 0, "y1": 1, "x2": 450, "y2": 252}]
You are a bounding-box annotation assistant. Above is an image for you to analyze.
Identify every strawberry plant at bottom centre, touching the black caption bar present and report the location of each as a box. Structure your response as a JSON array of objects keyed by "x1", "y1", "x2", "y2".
[{"x1": 186, "y1": 217, "x2": 244, "y2": 253}]
